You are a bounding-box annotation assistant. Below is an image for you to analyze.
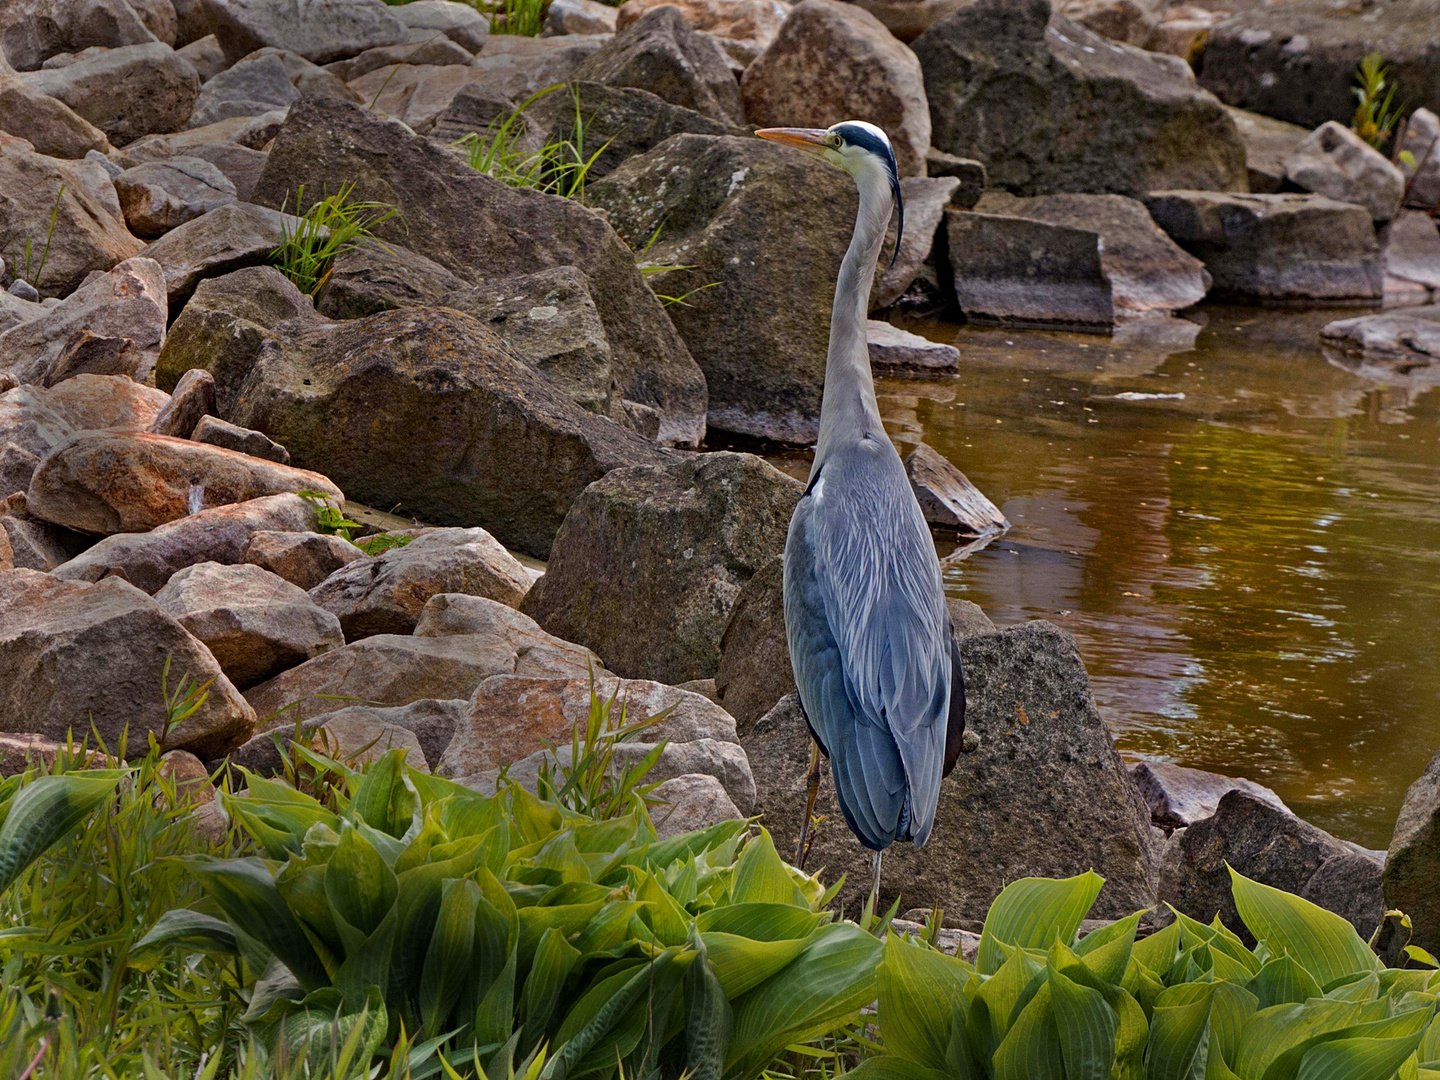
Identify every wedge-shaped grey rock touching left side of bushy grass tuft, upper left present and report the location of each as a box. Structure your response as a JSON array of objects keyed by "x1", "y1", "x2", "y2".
[{"x1": 143, "y1": 203, "x2": 311, "y2": 312}]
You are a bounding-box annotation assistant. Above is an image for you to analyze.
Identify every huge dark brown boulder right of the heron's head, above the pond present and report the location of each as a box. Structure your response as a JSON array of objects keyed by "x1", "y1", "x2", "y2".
[{"x1": 913, "y1": 0, "x2": 1246, "y2": 194}]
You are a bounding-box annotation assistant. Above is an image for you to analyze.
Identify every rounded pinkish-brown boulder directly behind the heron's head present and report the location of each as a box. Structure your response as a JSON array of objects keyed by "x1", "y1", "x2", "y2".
[{"x1": 740, "y1": 0, "x2": 930, "y2": 176}]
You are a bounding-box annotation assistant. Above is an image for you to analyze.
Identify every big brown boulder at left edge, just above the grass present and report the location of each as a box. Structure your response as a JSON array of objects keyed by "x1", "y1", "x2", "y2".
[{"x1": 0, "y1": 570, "x2": 255, "y2": 757}]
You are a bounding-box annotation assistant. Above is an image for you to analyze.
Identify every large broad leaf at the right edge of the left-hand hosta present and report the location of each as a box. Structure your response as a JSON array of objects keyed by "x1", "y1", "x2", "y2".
[{"x1": 725, "y1": 923, "x2": 881, "y2": 1080}]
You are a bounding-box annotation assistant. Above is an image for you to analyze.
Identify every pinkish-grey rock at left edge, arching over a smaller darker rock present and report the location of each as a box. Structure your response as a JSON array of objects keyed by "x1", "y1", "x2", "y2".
[{"x1": 0, "y1": 258, "x2": 166, "y2": 383}]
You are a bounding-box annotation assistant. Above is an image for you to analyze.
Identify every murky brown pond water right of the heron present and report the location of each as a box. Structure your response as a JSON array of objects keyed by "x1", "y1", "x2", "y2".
[{"x1": 772, "y1": 307, "x2": 1440, "y2": 848}]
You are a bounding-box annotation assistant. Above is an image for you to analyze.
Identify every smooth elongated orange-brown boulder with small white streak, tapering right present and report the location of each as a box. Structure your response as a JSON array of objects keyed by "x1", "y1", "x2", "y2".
[{"x1": 27, "y1": 431, "x2": 344, "y2": 536}]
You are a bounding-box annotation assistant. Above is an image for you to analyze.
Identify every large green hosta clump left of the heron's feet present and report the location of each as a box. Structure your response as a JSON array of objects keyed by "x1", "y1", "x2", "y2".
[{"x1": 138, "y1": 750, "x2": 881, "y2": 1080}]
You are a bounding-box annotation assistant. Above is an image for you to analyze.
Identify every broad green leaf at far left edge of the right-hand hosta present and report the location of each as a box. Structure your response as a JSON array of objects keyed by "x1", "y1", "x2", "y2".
[{"x1": 876, "y1": 935, "x2": 971, "y2": 1070}]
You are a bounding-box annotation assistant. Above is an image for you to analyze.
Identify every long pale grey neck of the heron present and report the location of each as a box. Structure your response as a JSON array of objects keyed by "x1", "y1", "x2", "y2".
[{"x1": 811, "y1": 168, "x2": 894, "y2": 475}]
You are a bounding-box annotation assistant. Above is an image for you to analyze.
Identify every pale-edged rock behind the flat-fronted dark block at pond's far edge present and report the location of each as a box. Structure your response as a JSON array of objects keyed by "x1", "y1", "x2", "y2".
[{"x1": 973, "y1": 193, "x2": 1211, "y2": 318}]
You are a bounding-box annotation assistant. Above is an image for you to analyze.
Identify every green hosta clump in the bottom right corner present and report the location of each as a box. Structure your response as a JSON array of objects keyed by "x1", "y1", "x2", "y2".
[{"x1": 851, "y1": 870, "x2": 1440, "y2": 1080}]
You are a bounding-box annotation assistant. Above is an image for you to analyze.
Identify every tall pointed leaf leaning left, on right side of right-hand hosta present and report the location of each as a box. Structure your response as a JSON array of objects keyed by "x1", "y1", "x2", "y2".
[{"x1": 1230, "y1": 868, "x2": 1380, "y2": 986}]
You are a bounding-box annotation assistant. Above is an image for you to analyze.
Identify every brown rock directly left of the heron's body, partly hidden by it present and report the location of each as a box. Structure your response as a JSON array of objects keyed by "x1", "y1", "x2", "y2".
[{"x1": 714, "y1": 556, "x2": 795, "y2": 734}]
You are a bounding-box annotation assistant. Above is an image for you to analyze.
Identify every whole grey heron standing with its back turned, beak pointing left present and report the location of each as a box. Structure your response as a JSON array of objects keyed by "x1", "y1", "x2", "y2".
[{"x1": 756, "y1": 121, "x2": 965, "y2": 907}]
